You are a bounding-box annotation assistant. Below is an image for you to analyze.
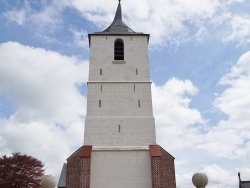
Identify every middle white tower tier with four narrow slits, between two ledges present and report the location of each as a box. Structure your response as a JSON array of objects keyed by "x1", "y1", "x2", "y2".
[{"x1": 87, "y1": 82, "x2": 153, "y2": 117}]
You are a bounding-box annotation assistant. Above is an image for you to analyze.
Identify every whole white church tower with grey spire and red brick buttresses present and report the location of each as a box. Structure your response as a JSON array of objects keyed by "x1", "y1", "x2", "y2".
[{"x1": 58, "y1": 0, "x2": 176, "y2": 188}]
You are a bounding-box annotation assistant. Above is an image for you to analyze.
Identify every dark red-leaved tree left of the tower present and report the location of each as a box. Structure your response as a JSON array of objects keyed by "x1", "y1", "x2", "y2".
[{"x1": 0, "y1": 153, "x2": 44, "y2": 188}]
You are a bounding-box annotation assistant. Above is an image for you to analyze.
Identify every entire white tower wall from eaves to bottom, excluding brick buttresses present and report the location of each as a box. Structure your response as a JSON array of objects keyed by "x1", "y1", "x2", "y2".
[{"x1": 84, "y1": 35, "x2": 156, "y2": 188}]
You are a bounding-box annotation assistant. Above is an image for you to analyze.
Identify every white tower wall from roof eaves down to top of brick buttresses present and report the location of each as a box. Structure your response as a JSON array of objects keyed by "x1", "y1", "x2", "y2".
[{"x1": 84, "y1": 35, "x2": 156, "y2": 146}]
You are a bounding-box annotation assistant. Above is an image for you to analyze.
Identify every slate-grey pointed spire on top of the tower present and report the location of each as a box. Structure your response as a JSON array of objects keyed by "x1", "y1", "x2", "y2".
[{"x1": 102, "y1": 0, "x2": 136, "y2": 34}]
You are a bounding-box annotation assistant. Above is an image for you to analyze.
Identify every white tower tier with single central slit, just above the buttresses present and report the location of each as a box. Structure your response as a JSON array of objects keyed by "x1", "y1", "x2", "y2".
[{"x1": 84, "y1": 117, "x2": 155, "y2": 146}]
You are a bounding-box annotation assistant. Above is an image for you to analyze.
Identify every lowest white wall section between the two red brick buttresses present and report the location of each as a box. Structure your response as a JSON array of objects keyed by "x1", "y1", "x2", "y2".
[{"x1": 90, "y1": 150, "x2": 152, "y2": 188}]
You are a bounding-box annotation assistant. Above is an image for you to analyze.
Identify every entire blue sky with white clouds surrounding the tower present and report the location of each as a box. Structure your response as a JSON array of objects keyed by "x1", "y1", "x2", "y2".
[{"x1": 0, "y1": 0, "x2": 250, "y2": 188}]
